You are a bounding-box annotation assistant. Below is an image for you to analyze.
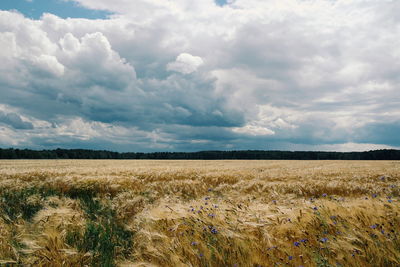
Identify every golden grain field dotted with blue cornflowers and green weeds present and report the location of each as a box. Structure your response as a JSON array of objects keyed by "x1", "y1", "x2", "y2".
[{"x1": 0, "y1": 160, "x2": 400, "y2": 266}]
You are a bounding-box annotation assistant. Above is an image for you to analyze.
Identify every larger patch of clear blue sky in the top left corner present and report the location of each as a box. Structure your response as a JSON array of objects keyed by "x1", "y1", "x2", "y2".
[{"x1": 0, "y1": 0, "x2": 111, "y2": 19}]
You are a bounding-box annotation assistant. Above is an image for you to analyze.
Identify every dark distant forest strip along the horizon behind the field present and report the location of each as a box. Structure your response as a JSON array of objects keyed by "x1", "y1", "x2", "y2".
[{"x1": 0, "y1": 148, "x2": 400, "y2": 160}]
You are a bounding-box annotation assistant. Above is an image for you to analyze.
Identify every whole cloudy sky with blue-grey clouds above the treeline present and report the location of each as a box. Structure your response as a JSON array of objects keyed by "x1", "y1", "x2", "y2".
[{"x1": 0, "y1": 0, "x2": 400, "y2": 152}]
